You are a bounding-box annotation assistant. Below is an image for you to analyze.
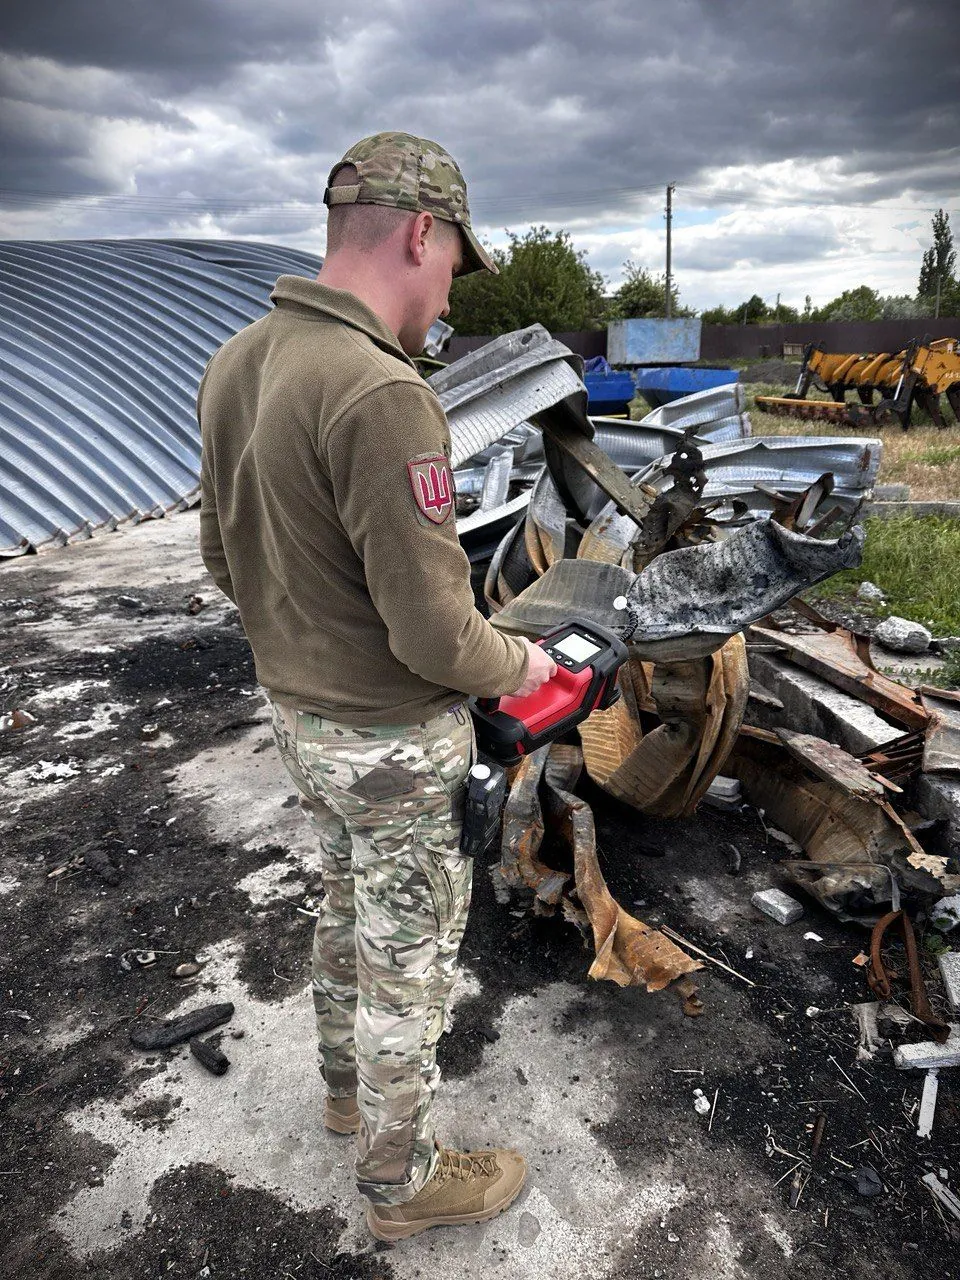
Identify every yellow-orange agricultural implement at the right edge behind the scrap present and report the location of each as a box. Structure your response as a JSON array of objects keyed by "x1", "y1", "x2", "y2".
[{"x1": 756, "y1": 338, "x2": 960, "y2": 430}]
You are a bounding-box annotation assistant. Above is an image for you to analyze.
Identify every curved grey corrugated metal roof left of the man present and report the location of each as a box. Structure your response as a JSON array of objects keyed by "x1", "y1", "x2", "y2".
[{"x1": 0, "y1": 239, "x2": 321, "y2": 556}]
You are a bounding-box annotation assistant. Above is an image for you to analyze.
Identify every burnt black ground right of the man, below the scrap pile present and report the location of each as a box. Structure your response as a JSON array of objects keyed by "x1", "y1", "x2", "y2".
[{"x1": 440, "y1": 762, "x2": 960, "y2": 1280}]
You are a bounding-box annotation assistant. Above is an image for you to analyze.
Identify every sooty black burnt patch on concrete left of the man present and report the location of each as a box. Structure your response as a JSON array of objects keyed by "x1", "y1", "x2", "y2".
[{"x1": 0, "y1": 614, "x2": 321, "y2": 1276}]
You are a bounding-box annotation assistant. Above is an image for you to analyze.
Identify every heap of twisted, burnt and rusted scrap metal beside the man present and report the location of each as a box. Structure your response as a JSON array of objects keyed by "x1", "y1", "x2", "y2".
[{"x1": 434, "y1": 326, "x2": 960, "y2": 1014}]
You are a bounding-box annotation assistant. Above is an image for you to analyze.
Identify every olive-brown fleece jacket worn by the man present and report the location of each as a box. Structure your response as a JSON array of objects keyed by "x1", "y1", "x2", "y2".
[{"x1": 197, "y1": 275, "x2": 527, "y2": 726}]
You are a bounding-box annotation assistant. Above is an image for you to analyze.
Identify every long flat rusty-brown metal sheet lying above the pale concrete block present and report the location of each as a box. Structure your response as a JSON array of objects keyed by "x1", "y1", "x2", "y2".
[{"x1": 750, "y1": 626, "x2": 929, "y2": 730}]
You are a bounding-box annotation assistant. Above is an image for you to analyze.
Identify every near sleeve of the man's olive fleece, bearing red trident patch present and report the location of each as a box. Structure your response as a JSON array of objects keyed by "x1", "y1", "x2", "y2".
[{"x1": 321, "y1": 381, "x2": 527, "y2": 698}]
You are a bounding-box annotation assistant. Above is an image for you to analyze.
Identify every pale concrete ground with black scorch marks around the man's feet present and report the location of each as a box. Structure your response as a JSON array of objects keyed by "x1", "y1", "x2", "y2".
[{"x1": 0, "y1": 513, "x2": 960, "y2": 1280}]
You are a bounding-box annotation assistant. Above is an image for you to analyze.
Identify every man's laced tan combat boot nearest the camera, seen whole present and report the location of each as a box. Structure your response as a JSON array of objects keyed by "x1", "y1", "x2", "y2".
[{"x1": 366, "y1": 1147, "x2": 526, "y2": 1240}]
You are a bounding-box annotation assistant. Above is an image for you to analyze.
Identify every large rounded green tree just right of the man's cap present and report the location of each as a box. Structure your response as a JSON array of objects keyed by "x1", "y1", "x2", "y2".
[{"x1": 448, "y1": 227, "x2": 604, "y2": 335}]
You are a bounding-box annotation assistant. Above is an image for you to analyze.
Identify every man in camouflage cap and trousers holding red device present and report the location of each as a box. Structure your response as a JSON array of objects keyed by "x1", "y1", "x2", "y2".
[{"x1": 198, "y1": 133, "x2": 556, "y2": 1240}]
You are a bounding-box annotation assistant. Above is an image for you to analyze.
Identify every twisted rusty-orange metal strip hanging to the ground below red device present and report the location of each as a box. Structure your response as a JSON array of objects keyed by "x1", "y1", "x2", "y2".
[{"x1": 500, "y1": 742, "x2": 703, "y2": 1016}]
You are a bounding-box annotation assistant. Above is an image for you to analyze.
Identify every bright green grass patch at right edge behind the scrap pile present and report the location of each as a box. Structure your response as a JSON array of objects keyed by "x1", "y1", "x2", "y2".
[{"x1": 817, "y1": 516, "x2": 960, "y2": 635}]
